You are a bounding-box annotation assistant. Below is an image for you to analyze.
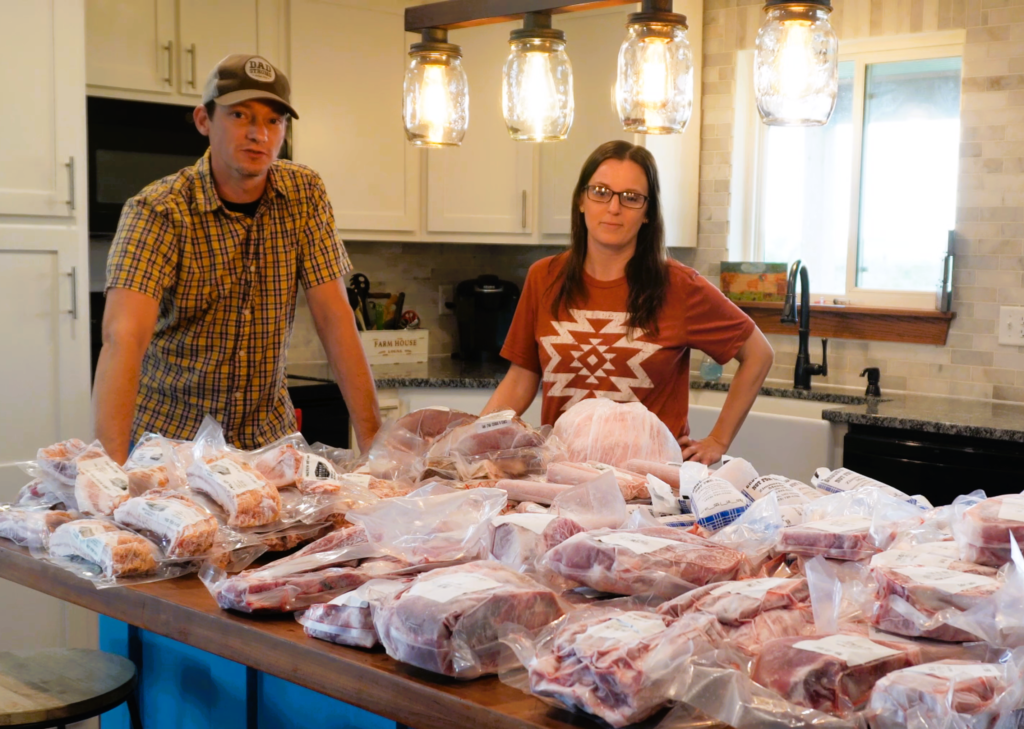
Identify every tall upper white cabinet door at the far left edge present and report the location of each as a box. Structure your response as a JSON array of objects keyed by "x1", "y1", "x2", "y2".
[{"x1": 0, "y1": 0, "x2": 87, "y2": 219}]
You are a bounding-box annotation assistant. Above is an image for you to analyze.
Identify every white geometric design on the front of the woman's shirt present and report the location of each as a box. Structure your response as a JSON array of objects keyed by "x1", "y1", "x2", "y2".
[{"x1": 541, "y1": 309, "x2": 662, "y2": 411}]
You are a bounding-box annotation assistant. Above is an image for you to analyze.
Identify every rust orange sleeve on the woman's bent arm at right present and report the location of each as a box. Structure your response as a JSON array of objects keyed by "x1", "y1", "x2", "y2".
[{"x1": 684, "y1": 272, "x2": 756, "y2": 365}]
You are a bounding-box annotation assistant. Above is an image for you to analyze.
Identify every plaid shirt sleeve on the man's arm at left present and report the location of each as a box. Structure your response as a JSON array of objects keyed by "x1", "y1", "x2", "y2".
[{"x1": 106, "y1": 197, "x2": 178, "y2": 301}]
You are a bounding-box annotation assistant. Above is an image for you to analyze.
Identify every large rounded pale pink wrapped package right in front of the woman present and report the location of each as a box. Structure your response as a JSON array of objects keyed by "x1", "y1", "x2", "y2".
[{"x1": 552, "y1": 397, "x2": 683, "y2": 468}]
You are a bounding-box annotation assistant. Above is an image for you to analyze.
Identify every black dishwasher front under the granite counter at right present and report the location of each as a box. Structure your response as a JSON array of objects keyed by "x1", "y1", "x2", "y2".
[{"x1": 843, "y1": 424, "x2": 1024, "y2": 506}]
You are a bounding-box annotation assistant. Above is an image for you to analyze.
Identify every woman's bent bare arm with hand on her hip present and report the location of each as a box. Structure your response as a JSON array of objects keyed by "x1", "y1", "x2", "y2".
[{"x1": 679, "y1": 328, "x2": 775, "y2": 466}]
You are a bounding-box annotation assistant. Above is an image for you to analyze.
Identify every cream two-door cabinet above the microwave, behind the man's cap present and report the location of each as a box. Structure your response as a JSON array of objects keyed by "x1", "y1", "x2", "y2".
[{"x1": 86, "y1": 0, "x2": 287, "y2": 104}]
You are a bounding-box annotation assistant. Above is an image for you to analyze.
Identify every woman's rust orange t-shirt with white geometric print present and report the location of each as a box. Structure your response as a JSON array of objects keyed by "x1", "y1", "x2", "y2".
[{"x1": 502, "y1": 254, "x2": 755, "y2": 438}]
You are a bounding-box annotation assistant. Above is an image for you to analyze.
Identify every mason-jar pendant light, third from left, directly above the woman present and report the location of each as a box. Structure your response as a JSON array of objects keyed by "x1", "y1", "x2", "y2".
[{"x1": 615, "y1": 0, "x2": 693, "y2": 134}]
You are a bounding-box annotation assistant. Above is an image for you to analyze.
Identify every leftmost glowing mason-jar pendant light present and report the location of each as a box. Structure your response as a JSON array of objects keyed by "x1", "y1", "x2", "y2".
[{"x1": 401, "y1": 28, "x2": 469, "y2": 146}]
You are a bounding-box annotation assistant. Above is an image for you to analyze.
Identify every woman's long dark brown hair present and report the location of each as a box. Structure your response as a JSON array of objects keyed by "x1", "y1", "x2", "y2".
[{"x1": 551, "y1": 139, "x2": 669, "y2": 335}]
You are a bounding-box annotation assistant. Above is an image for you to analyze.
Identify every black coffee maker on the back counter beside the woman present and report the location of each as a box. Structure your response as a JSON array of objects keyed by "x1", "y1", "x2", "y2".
[{"x1": 447, "y1": 274, "x2": 519, "y2": 362}]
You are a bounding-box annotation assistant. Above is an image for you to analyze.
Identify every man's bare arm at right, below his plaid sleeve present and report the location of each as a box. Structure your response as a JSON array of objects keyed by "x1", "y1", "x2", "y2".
[{"x1": 306, "y1": 278, "x2": 381, "y2": 453}]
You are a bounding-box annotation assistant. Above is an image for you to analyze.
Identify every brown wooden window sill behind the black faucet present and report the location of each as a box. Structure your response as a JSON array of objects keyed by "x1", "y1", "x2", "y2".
[{"x1": 736, "y1": 301, "x2": 956, "y2": 346}]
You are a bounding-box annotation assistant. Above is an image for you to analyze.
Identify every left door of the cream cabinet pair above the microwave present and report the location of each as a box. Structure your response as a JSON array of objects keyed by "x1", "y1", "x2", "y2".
[{"x1": 85, "y1": 0, "x2": 176, "y2": 94}]
